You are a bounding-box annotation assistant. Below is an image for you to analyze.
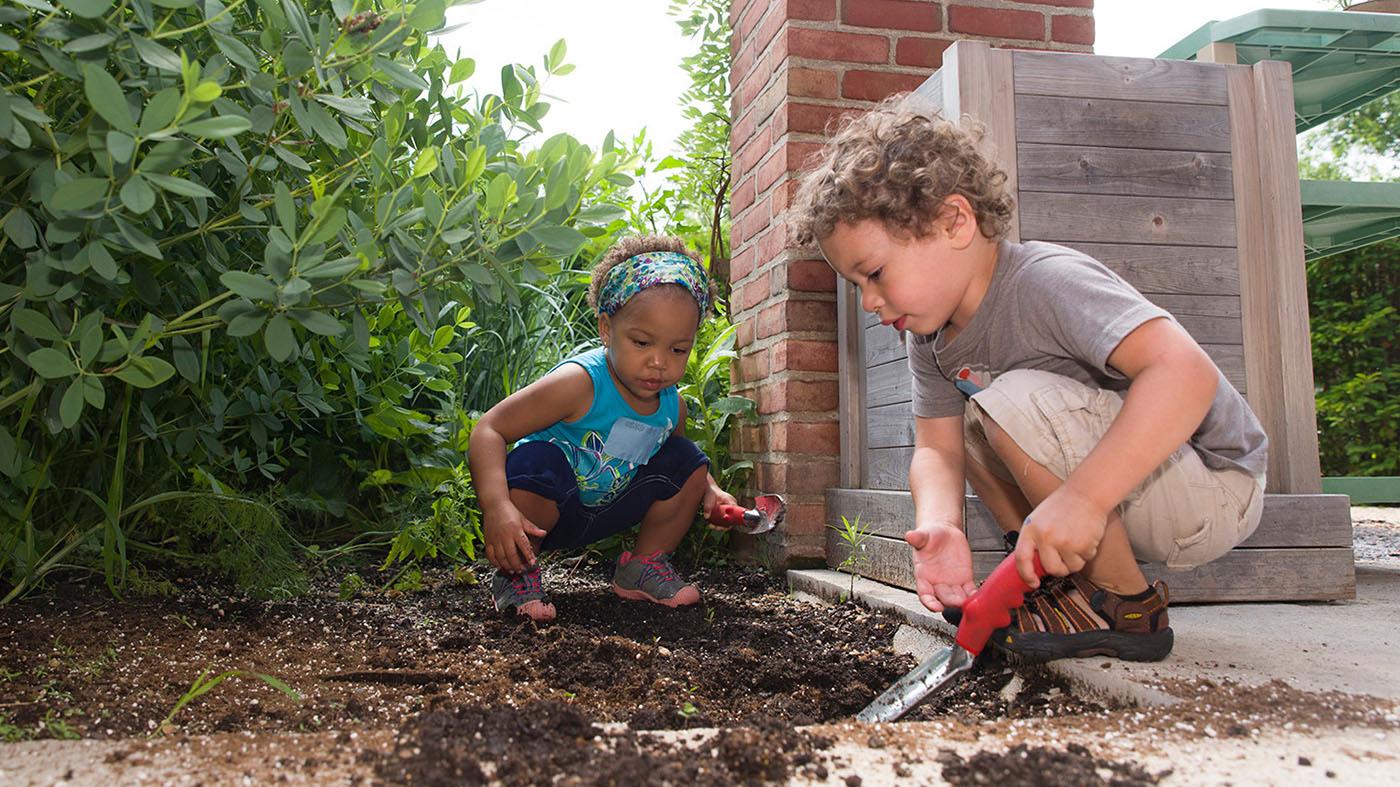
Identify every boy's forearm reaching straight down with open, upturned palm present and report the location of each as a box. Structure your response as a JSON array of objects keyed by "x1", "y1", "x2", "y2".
[{"x1": 904, "y1": 416, "x2": 976, "y2": 612}]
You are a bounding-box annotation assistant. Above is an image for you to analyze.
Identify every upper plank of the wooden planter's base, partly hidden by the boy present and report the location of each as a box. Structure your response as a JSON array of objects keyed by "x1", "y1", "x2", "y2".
[{"x1": 826, "y1": 489, "x2": 1351, "y2": 550}]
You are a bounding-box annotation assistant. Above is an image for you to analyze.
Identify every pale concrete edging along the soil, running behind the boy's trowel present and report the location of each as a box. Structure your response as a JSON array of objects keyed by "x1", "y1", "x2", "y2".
[{"x1": 787, "y1": 569, "x2": 1182, "y2": 706}]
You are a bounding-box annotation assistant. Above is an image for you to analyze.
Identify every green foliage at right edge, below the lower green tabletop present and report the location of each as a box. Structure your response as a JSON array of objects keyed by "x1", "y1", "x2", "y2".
[{"x1": 1308, "y1": 241, "x2": 1400, "y2": 476}]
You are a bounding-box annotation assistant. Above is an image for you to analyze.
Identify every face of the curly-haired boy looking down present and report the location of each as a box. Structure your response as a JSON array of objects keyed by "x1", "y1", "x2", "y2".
[{"x1": 819, "y1": 212, "x2": 969, "y2": 335}]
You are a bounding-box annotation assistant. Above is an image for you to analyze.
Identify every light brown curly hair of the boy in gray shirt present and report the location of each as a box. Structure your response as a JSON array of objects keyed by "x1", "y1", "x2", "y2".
[{"x1": 788, "y1": 94, "x2": 1012, "y2": 245}]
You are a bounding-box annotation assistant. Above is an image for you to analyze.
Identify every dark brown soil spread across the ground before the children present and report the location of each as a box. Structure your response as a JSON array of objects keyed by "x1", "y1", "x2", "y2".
[{"x1": 0, "y1": 557, "x2": 1396, "y2": 787}]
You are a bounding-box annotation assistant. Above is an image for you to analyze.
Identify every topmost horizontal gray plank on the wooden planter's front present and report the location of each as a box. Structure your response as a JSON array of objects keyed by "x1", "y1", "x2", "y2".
[{"x1": 1012, "y1": 52, "x2": 1226, "y2": 105}]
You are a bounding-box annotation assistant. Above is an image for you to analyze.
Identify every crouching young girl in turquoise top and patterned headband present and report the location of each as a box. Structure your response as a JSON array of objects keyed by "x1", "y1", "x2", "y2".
[{"x1": 468, "y1": 235, "x2": 735, "y2": 620}]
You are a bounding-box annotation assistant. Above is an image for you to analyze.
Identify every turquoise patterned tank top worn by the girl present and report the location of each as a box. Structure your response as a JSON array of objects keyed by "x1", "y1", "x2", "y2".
[{"x1": 521, "y1": 347, "x2": 680, "y2": 506}]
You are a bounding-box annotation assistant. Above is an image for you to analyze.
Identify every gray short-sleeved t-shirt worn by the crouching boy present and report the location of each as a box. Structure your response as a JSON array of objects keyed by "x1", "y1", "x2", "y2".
[{"x1": 907, "y1": 241, "x2": 1268, "y2": 479}]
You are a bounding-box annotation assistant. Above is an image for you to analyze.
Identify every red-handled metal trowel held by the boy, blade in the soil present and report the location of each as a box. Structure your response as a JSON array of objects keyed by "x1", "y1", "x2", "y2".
[{"x1": 855, "y1": 555, "x2": 1046, "y2": 724}]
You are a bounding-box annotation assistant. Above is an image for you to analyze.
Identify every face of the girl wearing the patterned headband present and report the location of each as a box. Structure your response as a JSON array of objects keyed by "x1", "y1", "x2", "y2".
[{"x1": 598, "y1": 286, "x2": 700, "y2": 413}]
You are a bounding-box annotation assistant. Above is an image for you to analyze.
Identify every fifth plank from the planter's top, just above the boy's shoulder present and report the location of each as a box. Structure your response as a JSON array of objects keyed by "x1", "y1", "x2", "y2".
[{"x1": 1067, "y1": 242, "x2": 1239, "y2": 295}]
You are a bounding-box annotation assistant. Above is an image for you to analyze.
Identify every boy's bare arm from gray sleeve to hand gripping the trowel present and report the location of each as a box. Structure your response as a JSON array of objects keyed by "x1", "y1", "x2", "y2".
[{"x1": 1016, "y1": 318, "x2": 1219, "y2": 587}]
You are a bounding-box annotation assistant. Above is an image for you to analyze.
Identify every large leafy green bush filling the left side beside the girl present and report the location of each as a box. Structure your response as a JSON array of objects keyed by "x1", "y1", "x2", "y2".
[{"x1": 0, "y1": 0, "x2": 630, "y2": 598}]
